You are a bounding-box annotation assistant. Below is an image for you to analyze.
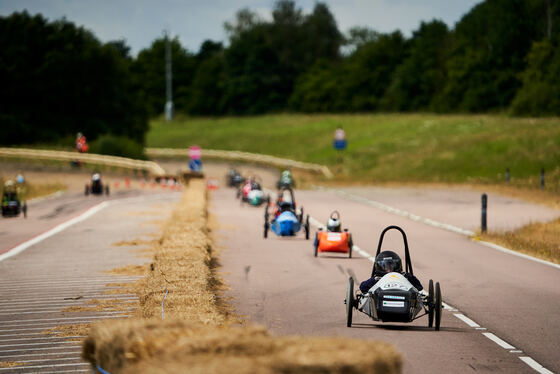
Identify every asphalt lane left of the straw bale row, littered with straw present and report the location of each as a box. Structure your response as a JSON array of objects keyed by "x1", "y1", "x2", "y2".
[{"x1": 0, "y1": 189, "x2": 180, "y2": 373}]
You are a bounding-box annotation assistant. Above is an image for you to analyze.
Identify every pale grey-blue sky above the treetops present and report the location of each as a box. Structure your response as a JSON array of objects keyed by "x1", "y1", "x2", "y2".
[{"x1": 0, "y1": 0, "x2": 482, "y2": 55}]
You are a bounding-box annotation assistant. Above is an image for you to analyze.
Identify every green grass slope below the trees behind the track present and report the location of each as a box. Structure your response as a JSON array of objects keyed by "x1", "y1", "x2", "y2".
[{"x1": 147, "y1": 114, "x2": 560, "y2": 190}]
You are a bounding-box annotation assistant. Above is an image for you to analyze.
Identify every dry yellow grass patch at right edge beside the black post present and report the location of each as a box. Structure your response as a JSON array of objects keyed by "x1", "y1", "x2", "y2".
[{"x1": 480, "y1": 219, "x2": 560, "y2": 264}]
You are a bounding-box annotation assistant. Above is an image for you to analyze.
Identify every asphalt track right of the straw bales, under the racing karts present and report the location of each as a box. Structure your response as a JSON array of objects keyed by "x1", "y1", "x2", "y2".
[{"x1": 211, "y1": 185, "x2": 560, "y2": 373}]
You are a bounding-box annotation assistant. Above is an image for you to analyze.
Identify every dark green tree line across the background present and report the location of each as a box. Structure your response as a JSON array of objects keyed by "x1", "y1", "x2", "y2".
[{"x1": 0, "y1": 0, "x2": 560, "y2": 144}]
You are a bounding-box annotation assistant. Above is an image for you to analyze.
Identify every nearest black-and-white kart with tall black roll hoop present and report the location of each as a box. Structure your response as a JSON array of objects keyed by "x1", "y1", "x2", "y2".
[{"x1": 344, "y1": 226, "x2": 442, "y2": 331}]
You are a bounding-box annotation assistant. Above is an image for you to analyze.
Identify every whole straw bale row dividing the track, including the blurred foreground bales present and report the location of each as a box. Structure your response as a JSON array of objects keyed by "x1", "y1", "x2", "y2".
[{"x1": 82, "y1": 180, "x2": 402, "y2": 374}]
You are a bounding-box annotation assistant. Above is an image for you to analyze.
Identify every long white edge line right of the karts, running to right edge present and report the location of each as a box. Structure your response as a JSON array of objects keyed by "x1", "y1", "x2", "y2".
[{"x1": 326, "y1": 187, "x2": 560, "y2": 269}]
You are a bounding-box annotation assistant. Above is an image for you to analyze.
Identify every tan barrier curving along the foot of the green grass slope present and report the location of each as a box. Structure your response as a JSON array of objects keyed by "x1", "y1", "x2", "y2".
[{"x1": 146, "y1": 148, "x2": 333, "y2": 178}]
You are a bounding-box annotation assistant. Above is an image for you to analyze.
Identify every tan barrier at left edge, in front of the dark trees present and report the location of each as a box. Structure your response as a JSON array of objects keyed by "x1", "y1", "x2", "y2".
[{"x1": 0, "y1": 148, "x2": 165, "y2": 176}]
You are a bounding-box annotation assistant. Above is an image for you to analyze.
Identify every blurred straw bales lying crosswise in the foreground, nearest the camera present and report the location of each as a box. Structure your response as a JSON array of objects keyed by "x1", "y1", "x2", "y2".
[{"x1": 83, "y1": 320, "x2": 402, "y2": 374}]
